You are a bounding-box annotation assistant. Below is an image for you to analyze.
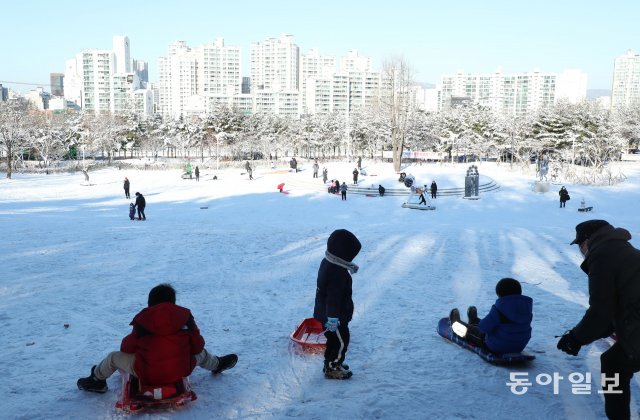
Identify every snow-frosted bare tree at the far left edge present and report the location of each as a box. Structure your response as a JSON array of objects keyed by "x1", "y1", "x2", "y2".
[{"x1": 0, "y1": 100, "x2": 30, "y2": 178}]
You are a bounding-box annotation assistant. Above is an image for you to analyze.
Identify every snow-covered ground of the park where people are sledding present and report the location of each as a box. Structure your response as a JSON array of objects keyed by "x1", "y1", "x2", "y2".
[{"x1": 0, "y1": 160, "x2": 640, "y2": 419}]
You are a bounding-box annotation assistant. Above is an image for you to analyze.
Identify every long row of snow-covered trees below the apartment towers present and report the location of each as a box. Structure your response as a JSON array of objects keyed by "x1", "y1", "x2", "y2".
[{"x1": 0, "y1": 94, "x2": 640, "y2": 182}]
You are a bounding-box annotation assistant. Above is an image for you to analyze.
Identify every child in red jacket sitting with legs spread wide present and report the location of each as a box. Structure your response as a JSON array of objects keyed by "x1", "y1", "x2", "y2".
[{"x1": 78, "y1": 284, "x2": 238, "y2": 393}]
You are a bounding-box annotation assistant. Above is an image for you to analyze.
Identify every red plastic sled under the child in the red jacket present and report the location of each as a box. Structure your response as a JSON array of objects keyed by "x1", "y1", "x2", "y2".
[{"x1": 116, "y1": 371, "x2": 198, "y2": 413}]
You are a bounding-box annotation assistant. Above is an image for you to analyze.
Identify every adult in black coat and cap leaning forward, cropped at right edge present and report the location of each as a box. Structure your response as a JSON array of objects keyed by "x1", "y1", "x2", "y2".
[{"x1": 558, "y1": 220, "x2": 640, "y2": 419}]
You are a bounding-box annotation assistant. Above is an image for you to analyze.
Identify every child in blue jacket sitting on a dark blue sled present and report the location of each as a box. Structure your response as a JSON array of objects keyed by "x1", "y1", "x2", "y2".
[{"x1": 449, "y1": 278, "x2": 533, "y2": 354}]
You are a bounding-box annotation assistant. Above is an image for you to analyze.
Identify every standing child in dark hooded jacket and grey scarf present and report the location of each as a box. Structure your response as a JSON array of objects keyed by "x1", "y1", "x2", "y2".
[{"x1": 313, "y1": 229, "x2": 362, "y2": 379}]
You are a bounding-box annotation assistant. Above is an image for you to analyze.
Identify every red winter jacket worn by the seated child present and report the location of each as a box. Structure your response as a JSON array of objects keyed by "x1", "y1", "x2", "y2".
[{"x1": 120, "y1": 303, "x2": 204, "y2": 385}]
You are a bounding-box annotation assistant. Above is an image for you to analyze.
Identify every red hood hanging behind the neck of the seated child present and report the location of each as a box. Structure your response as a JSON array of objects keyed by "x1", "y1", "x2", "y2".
[{"x1": 131, "y1": 303, "x2": 191, "y2": 335}]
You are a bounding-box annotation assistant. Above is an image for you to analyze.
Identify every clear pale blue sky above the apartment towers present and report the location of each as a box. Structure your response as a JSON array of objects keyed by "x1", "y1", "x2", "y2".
[{"x1": 0, "y1": 0, "x2": 640, "y2": 91}]
